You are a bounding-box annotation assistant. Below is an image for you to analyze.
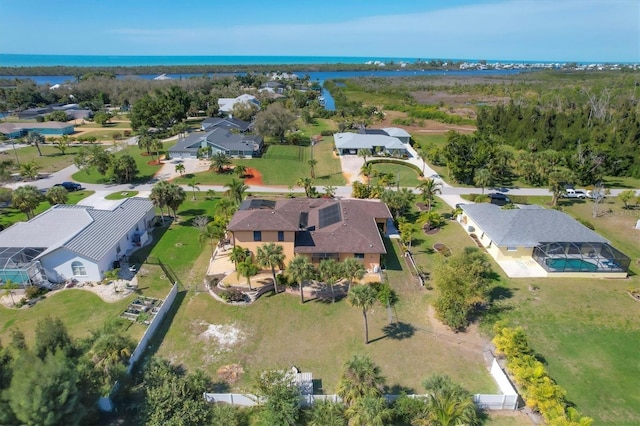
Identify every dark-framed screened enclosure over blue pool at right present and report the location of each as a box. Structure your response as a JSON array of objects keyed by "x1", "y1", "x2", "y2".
[{"x1": 533, "y1": 242, "x2": 631, "y2": 273}]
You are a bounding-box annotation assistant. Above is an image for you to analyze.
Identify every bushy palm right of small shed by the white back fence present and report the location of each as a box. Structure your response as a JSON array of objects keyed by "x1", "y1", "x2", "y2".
[{"x1": 336, "y1": 355, "x2": 384, "y2": 405}]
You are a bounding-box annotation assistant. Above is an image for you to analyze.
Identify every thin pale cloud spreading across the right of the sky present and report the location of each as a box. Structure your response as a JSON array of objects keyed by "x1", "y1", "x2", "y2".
[{"x1": 104, "y1": 0, "x2": 640, "y2": 61}]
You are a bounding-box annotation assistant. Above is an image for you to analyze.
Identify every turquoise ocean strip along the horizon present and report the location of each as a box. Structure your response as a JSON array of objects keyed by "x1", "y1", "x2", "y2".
[{"x1": 0, "y1": 53, "x2": 424, "y2": 67}]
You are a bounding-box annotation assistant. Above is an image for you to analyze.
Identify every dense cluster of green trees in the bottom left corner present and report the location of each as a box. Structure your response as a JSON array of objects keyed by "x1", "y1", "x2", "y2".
[{"x1": 0, "y1": 317, "x2": 135, "y2": 425}]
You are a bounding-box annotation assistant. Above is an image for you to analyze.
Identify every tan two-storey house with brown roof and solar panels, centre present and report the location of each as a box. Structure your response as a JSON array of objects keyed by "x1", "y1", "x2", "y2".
[{"x1": 227, "y1": 198, "x2": 391, "y2": 272}]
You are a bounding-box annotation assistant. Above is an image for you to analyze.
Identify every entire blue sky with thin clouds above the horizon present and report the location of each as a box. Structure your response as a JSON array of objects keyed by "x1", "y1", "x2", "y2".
[{"x1": 0, "y1": 0, "x2": 640, "y2": 62}]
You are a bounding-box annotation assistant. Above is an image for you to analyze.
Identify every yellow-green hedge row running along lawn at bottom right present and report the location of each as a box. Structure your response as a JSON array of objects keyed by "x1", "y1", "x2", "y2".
[{"x1": 493, "y1": 323, "x2": 593, "y2": 426}]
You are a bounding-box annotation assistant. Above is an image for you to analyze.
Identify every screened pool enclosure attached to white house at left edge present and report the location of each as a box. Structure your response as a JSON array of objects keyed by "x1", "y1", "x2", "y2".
[{"x1": 0, "y1": 247, "x2": 47, "y2": 286}]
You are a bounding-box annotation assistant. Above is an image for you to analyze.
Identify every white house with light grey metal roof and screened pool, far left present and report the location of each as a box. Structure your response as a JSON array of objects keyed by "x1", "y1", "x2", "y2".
[{"x1": 0, "y1": 197, "x2": 155, "y2": 285}]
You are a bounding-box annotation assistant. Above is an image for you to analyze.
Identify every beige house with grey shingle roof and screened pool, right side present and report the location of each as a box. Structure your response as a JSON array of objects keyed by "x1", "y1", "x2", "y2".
[{"x1": 458, "y1": 203, "x2": 630, "y2": 278}]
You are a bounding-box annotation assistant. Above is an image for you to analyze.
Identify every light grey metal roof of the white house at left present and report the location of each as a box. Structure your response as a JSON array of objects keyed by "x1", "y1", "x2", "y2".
[{"x1": 0, "y1": 197, "x2": 153, "y2": 260}]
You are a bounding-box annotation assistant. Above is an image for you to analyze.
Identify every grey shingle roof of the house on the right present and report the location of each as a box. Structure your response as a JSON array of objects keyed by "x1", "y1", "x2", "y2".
[{"x1": 461, "y1": 203, "x2": 609, "y2": 247}]
